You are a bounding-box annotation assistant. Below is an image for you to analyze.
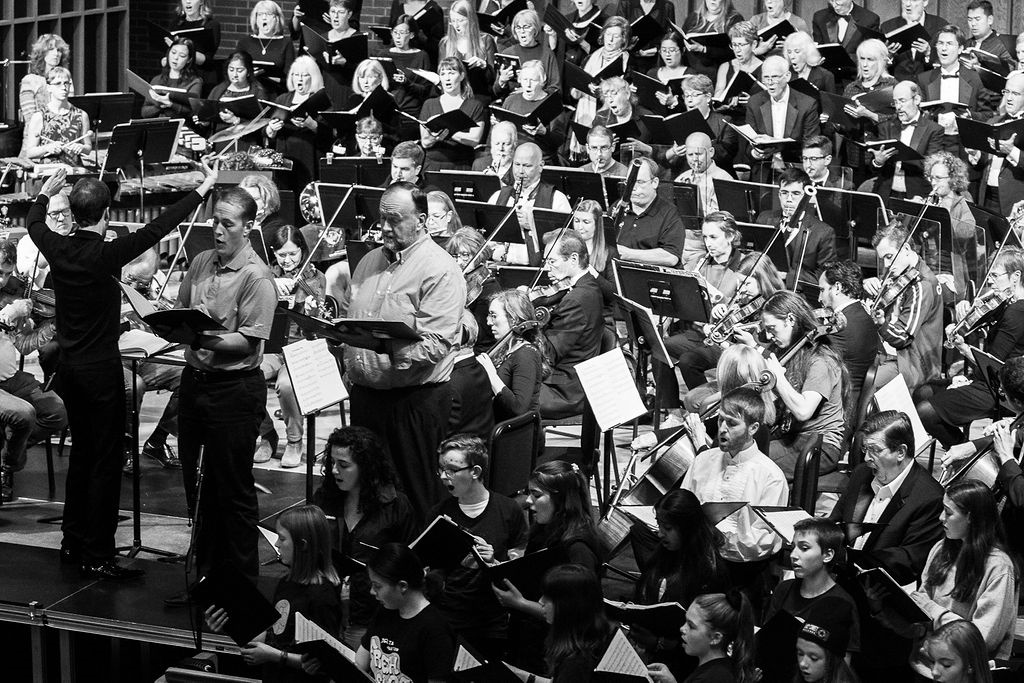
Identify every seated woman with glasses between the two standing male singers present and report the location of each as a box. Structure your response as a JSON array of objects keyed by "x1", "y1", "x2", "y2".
[{"x1": 253, "y1": 225, "x2": 327, "y2": 468}]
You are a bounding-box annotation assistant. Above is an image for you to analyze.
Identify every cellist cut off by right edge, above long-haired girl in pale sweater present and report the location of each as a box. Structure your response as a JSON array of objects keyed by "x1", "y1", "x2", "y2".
[{"x1": 942, "y1": 356, "x2": 1024, "y2": 554}]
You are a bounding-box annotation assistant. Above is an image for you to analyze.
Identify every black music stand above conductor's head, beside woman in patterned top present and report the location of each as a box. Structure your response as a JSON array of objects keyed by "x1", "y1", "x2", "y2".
[{"x1": 99, "y1": 119, "x2": 184, "y2": 214}]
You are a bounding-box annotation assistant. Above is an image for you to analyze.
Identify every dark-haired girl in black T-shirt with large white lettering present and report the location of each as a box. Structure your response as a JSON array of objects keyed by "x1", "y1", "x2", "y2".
[{"x1": 355, "y1": 543, "x2": 455, "y2": 683}]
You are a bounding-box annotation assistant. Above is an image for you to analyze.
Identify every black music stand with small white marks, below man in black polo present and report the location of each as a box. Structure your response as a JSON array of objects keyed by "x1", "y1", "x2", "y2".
[{"x1": 612, "y1": 259, "x2": 711, "y2": 323}]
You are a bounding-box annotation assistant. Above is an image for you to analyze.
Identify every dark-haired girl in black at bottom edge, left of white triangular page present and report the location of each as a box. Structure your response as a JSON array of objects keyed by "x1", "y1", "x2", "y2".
[{"x1": 541, "y1": 564, "x2": 613, "y2": 683}]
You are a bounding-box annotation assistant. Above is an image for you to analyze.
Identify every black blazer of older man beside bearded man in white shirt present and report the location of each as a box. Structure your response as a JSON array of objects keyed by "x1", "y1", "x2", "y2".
[{"x1": 829, "y1": 463, "x2": 942, "y2": 584}]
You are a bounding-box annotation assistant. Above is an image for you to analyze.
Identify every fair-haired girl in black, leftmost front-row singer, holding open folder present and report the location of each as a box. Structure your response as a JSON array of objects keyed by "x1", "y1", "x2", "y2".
[{"x1": 206, "y1": 505, "x2": 341, "y2": 681}]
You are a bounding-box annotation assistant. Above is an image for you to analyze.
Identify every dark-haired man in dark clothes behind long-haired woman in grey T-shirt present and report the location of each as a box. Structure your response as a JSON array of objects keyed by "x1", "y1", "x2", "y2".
[{"x1": 818, "y1": 261, "x2": 882, "y2": 418}]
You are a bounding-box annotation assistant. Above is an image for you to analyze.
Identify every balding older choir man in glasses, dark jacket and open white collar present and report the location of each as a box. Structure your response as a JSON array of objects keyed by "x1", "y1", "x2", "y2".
[{"x1": 746, "y1": 54, "x2": 821, "y2": 182}]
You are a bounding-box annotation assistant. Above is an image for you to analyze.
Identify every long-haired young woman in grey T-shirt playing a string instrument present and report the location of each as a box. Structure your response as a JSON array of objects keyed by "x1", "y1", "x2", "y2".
[{"x1": 761, "y1": 292, "x2": 850, "y2": 481}]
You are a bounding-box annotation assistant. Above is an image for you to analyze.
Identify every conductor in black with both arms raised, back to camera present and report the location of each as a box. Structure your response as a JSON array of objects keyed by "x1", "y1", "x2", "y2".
[{"x1": 26, "y1": 166, "x2": 217, "y2": 580}]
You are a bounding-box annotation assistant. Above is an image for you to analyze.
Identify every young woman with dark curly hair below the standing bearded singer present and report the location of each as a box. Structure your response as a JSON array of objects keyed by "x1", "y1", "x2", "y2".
[{"x1": 313, "y1": 427, "x2": 417, "y2": 649}]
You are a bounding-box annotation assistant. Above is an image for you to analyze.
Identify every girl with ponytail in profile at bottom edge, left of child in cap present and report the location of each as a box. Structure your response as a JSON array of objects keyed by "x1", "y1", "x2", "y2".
[{"x1": 647, "y1": 590, "x2": 760, "y2": 683}]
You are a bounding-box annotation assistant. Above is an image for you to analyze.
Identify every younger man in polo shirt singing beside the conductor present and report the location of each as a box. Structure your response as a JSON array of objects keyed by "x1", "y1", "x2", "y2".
[{"x1": 177, "y1": 187, "x2": 278, "y2": 579}]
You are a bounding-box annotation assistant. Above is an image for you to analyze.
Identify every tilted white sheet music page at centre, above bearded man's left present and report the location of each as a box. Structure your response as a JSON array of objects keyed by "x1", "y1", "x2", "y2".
[{"x1": 577, "y1": 347, "x2": 647, "y2": 431}]
